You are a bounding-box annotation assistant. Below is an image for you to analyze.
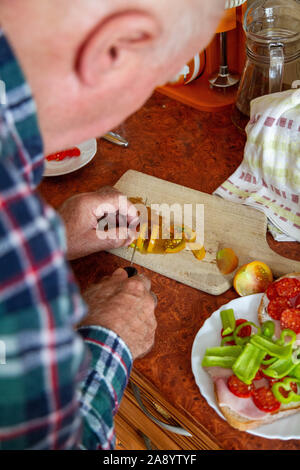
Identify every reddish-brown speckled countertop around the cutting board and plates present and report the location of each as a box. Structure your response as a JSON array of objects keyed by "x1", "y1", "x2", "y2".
[{"x1": 40, "y1": 92, "x2": 300, "y2": 450}]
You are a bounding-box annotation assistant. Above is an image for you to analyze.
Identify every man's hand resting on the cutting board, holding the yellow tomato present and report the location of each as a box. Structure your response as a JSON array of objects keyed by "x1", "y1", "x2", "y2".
[{"x1": 58, "y1": 187, "x2": 139, "y2": 260}]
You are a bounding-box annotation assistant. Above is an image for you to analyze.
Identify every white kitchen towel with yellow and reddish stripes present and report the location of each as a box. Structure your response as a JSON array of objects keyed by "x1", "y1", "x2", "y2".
[{"x1": 215, "y1": 89, "x2": 300, "y2": 242}]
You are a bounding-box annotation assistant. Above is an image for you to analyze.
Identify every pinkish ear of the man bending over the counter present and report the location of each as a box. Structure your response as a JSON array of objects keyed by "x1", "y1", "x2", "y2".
[{"x1": 76, "y1": 11, "x2": 160, "y2": 86}]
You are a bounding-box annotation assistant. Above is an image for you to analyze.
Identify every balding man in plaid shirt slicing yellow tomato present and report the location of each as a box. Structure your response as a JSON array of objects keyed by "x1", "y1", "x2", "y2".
[{"x1": 0, "y1": 0, "x2": 224, "y2": 449}]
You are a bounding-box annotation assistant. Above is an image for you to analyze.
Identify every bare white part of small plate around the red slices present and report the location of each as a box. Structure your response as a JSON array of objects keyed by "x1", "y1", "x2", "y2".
[{"x1": 44, "y1": 139, "x2": 97, "y2": 176}]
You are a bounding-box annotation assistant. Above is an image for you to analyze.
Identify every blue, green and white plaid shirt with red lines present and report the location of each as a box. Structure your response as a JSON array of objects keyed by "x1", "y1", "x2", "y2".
[{"x1": 0, "y1": 30, "x2": 132, "y2": 449}]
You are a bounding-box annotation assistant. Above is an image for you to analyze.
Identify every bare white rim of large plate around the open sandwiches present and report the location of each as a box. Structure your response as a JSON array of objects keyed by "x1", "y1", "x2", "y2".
[{"x1": 192, "y1": 294, "x2": 300, "y2": 440}]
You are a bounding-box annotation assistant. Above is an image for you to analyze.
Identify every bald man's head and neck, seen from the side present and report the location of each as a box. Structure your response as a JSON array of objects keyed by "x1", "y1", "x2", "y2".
[{"x1": 0, "y1": 0, "x2": 225, "y2": 153}]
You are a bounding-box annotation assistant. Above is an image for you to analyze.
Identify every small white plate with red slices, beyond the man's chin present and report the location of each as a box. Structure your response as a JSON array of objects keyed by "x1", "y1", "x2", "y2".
[{"x1": 44, "y1": 139, "x2": 97, "y2": 176}]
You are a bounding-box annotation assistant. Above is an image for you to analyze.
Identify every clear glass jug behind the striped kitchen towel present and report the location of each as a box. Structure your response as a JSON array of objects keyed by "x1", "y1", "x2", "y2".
[{"x1": 236, "y1": 0, "x2": 300, "y2": 116}]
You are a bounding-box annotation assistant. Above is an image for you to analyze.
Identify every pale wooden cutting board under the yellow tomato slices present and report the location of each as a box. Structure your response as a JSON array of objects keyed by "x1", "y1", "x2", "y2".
[{"x1": 111, "y1": 170, "x2": 300, "y2": 295}]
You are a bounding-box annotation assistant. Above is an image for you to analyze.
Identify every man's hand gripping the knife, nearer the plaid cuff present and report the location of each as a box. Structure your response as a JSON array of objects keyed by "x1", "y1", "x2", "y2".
[{"x1": 79, "y1": 268, "x2": 157, "y2": 359}]
